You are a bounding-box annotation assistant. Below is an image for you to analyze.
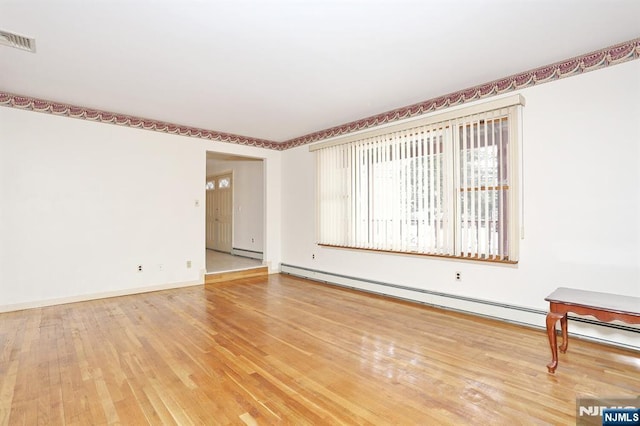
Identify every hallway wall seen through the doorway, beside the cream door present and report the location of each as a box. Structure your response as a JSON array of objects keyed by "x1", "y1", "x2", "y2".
[{"x1": 207, "y1": 160, "x2": 265, "y2": 252}]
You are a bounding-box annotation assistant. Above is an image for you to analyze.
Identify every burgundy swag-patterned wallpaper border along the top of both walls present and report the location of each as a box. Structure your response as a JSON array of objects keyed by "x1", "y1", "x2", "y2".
[{"x1": 0, "y1": 38, "x2": 640, "y2": 150}]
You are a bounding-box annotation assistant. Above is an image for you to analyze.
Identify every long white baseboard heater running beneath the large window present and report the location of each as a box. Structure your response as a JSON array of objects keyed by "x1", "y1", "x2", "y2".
[{"x1": 280, "y1": 263, "x2": 640, "y2": 351}]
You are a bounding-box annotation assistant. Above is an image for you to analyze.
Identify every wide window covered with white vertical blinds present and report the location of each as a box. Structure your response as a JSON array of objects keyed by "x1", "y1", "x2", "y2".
[{"x1": 311, "y1": 95, "x2": 524, "y2": 262}]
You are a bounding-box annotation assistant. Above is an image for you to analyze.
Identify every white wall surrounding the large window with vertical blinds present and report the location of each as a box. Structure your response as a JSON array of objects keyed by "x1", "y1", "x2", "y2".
[{"x1": 282, "y1": 61, "x2": 640, "y2": 347}]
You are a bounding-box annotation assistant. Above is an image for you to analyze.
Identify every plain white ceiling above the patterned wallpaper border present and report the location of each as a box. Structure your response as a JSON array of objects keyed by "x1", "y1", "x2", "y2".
[{"x1": 0, "y1": 0, "x2": 640, "y2": 141}]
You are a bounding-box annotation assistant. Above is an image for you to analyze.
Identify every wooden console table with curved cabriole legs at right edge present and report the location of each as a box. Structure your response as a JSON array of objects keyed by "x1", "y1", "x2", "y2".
[{"x1": 544, "y1": 287, "x2": 640, "y2": 373}]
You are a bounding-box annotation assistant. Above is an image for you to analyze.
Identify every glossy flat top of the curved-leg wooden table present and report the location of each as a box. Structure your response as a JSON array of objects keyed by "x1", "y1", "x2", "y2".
[{"x1": 544, "y1": 287, "x2": 640, "y2": 314}]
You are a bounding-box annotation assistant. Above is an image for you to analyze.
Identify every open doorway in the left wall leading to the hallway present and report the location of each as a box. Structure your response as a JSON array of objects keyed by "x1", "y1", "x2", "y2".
[{"x1": 205, "y1": 152, "x2": 265, "y2": 273}]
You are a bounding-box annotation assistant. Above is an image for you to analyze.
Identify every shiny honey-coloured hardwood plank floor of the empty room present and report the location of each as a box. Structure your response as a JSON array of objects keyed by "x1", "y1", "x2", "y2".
[{"x1": 0, "y1": 275, "x2": 640, "y2": 425}]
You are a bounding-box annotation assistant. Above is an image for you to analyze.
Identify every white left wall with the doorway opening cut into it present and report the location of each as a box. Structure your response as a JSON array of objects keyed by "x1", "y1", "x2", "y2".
[{"x1": 0, "y1": 108, "x2": 281, "y2": 310}]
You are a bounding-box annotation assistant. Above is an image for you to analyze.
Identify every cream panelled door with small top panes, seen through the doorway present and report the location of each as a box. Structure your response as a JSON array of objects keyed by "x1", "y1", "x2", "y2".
[{"x1": 206, "y1": 173, "x2": 233, "y2": 253}]
